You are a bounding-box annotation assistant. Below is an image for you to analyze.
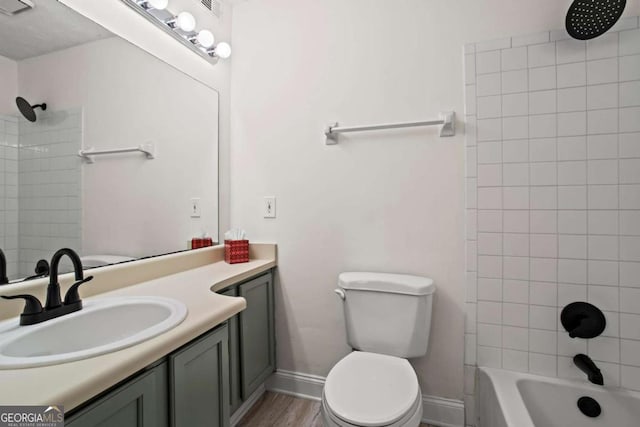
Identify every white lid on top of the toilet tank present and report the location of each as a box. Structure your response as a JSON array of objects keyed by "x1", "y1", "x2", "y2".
[{"x1": 338, "y1": 272, "x2": 436, "y2": 295}]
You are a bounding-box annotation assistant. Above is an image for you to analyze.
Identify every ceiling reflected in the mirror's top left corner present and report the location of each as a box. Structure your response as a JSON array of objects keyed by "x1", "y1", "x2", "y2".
[{"x1": 0, "y1": 0, "x2": 113, "y2": 60}]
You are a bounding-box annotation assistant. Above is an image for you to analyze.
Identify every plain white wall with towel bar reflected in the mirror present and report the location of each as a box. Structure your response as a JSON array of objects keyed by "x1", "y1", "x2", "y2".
[{"x1": 18, "y1": 37, "x2": 218, "y2": 257}]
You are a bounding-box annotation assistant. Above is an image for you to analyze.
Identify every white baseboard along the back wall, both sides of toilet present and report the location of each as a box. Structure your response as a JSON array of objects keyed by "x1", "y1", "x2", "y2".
[{"x1": 265, "y1": 370, "x2": 464, "y2": 427}]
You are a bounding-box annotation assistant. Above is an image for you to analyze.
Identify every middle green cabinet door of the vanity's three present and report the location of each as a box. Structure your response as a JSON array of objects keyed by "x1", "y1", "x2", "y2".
[{"x1": 169, "y1": 325, "x2": 229, "y2": 427}]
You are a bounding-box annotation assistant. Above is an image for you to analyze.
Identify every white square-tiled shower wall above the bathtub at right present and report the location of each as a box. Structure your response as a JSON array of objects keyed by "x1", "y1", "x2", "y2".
[{"x1": 465, "y1": 17, "x2": 640, "y2": 425}]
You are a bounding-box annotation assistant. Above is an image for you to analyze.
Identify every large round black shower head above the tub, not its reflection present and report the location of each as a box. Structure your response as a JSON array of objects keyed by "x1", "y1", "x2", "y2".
[{"x1": 565, "y1": 0, "x2": 627, "y2": 40}]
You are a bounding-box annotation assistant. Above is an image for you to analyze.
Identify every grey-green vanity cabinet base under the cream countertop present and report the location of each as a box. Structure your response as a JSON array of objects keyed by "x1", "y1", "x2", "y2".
[{"x1": 65, "y1": 272, "x2": 275, "y2": 427}]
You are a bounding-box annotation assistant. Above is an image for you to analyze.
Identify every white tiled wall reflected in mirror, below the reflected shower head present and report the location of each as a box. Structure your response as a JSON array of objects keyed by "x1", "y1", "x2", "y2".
[{"x1": 18, "y1": 110, "x2": 82, "y2": 277}]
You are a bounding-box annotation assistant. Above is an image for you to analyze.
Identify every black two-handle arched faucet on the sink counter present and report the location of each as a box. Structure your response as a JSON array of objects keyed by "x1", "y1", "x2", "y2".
[{"x1": 2, "y1": 248, "x2": 93, "y2": 325}]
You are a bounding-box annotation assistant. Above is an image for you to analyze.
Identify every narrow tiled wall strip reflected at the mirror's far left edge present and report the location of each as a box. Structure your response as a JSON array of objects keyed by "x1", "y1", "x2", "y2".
[{"x1": 0, "y1": 116, "x2": 18, "y2": 279}]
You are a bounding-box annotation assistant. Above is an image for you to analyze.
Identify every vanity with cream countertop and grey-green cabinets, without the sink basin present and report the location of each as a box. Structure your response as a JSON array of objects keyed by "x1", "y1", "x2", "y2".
[{"x1": 0, "y1": 244, "x2": 276, "y2": 427}]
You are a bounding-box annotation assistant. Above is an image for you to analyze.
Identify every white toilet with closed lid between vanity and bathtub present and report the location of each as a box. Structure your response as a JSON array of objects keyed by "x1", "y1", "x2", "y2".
[{"x1": 321, "y1": 272, "x2": 435, "y2": 427}]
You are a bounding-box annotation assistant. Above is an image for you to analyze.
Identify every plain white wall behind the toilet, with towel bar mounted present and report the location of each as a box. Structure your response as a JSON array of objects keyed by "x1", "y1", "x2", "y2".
[{"x1": 231, "y1": 0, "x2": 640, "y2": 399}]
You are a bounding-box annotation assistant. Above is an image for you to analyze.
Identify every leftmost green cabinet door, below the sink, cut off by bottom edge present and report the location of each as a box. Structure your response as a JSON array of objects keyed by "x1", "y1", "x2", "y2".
[{"x1": 65, "y1": 363, "x2": 168, "y2": 427}]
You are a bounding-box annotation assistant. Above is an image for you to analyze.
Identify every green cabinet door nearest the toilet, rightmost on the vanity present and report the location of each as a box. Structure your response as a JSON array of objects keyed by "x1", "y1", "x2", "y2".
[{"x1": 238, "y1": 273, "x2": 275, "y2": 400}]
